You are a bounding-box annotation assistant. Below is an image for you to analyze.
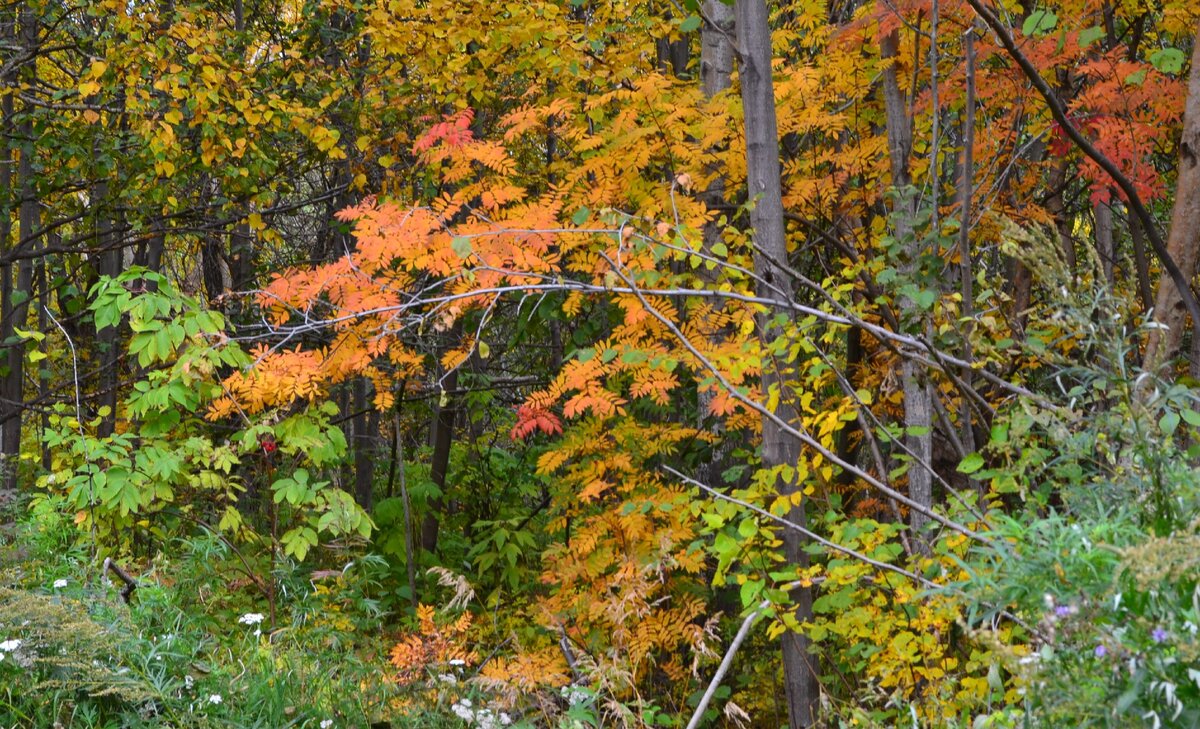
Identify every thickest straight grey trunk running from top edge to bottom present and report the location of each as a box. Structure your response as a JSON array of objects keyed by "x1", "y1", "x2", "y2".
[{"x1": 734, "y1": 0, "x2": 821, "y2": 729}]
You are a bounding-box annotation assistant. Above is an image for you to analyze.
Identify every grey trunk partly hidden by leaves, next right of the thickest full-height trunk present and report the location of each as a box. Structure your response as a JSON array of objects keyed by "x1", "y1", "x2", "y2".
[{"x1": 880, "y1": 31, "x2": 934, "y2": 552}]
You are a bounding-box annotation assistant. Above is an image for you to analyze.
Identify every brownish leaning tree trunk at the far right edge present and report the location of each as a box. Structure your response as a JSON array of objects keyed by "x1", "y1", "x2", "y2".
[{"x1": 1142, "y1": 27, "x2": 1200, "y2": 372}]
